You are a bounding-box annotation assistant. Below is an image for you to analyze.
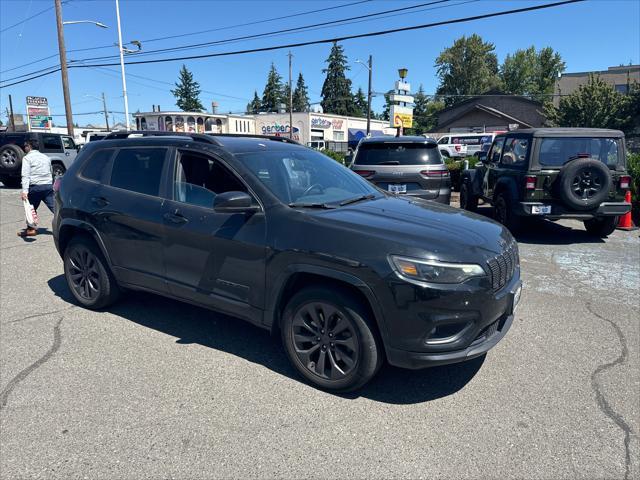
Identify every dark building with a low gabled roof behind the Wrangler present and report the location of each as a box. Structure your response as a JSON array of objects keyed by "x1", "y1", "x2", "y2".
[{"x1": 434, "y1": 92, "x2": 545, "y2": 133}]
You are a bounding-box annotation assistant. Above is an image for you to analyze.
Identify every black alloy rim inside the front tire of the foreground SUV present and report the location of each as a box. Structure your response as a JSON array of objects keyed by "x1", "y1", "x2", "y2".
[{"x1": 293, "y1": 302, "x2": 359, "y2": 380}]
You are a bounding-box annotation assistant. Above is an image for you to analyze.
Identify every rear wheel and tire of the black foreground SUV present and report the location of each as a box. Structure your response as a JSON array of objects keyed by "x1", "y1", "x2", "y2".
[{"x1": 63, "y1": 237, "x2": 120, "y2": 310}]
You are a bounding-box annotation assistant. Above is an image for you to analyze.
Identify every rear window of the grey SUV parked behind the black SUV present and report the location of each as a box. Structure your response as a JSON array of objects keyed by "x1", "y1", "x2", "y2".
[{"x1": 355, "y1": 142, "x2": 442, "y2": 165}]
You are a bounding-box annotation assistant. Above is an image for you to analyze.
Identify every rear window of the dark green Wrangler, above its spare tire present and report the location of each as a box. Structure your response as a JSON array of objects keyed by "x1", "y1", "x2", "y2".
[{"x1": 538, "y1": 137, "x2": 624, "y2": 169}]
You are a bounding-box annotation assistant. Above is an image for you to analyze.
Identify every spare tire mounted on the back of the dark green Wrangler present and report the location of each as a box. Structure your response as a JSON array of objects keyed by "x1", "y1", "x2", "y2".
[{"x1": 557, "y1": 158, "x2": 611, "y2": 210}]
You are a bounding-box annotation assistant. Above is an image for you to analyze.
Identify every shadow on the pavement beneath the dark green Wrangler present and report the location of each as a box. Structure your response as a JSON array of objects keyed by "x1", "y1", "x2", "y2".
[{"x1": 476, "y1": 206, "x2": 605, "y2": 245}]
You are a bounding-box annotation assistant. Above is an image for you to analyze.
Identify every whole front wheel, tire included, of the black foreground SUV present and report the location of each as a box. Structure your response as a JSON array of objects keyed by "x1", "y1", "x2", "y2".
[{"x1": 281, "y1": 286, "x2": 383, "y2": 392}]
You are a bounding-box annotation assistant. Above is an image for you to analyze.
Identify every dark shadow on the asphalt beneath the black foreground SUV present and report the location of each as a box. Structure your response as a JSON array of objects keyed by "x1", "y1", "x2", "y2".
[{"x1": 48, "y1": 275, "x2": 485, "y2": 404}]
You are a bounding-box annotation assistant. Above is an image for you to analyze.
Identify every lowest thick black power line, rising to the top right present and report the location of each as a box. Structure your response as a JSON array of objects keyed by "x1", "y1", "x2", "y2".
[{"x1": 0, "y1": 0, "x2": 585, "y2": 88}]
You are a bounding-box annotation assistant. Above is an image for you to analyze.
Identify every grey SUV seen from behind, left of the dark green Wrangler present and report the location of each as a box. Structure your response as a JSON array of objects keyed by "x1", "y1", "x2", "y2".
[{"x1": 351, "y1": 136, "x2": 451, "y2": 205}]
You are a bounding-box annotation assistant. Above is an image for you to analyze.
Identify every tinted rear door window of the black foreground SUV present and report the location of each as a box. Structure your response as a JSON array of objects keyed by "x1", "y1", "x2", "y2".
[{"x1": 111, "y1": 147, "x2": 167, "y2": 196}]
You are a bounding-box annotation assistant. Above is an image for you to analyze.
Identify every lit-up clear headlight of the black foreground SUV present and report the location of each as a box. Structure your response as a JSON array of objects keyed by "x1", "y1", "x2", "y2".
[{"x1": 389, "y1": 255, "x2": 486, "y2": 285}]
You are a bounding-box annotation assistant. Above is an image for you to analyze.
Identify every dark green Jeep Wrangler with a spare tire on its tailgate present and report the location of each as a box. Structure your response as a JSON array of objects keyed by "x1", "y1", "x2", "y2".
[{"x1": 460, "y1": 128, "x2": 631, "y2": 237}]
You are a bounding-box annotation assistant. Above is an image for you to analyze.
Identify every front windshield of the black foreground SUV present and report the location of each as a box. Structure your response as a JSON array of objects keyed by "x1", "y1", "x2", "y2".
[{"x1": 236, "y1": 148, "x2": 382, "y2": 208}]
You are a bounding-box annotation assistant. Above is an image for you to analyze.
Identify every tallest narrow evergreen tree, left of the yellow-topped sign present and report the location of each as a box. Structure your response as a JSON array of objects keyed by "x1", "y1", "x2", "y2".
[{"x1": 320, "y1": 42, "x2": 355, "y2": 115}]
